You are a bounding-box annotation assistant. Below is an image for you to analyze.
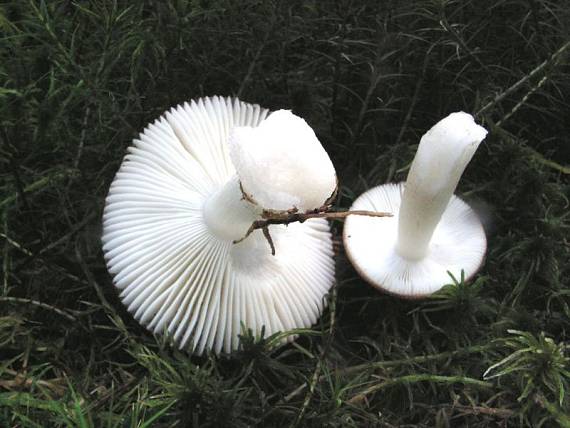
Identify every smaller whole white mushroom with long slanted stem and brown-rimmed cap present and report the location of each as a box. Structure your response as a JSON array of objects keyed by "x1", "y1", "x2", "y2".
[{"x1": 344, "y1": 112, "x2": 487, "y2": 298}]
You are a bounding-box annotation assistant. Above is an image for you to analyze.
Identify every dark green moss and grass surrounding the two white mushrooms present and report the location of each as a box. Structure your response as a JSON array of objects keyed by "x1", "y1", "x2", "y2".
[{"x1": 0, "y1": 0, "x2": 570, "y2": 427}]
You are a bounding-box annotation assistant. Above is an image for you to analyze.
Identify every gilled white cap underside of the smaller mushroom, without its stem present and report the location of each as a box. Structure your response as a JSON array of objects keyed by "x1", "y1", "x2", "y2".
[{"x1": 343, "y1": 183, "x2": 487, "y2": 298}]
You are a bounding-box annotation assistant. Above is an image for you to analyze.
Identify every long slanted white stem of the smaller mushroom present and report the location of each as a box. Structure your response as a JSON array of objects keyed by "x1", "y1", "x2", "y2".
[{"x1": 396, "y1": 112, "x2": 487, "y2": 260}]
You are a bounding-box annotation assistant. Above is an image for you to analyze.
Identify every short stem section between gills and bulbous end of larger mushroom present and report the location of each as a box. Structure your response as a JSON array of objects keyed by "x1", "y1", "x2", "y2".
[{"x1": 202, "y1": 175, "x2": 262, "y2": 241}]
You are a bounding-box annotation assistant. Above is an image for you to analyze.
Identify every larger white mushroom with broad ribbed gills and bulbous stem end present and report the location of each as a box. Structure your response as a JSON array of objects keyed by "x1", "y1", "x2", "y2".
[{"x1": 102, "y1": 97, "x2": 336, "y2": 354}]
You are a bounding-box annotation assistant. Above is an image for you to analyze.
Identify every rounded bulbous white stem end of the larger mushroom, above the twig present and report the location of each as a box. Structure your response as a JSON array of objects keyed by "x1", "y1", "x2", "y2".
[{"x1": 230, "y1": 110, "x2": 337, "y2": 212}]
